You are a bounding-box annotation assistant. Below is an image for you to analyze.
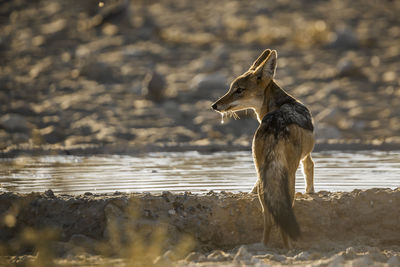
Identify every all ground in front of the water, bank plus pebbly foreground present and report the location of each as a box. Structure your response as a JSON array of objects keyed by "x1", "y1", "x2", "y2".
[{"x1": 0, "y1": 188, "x2": 400, "y2": 266}]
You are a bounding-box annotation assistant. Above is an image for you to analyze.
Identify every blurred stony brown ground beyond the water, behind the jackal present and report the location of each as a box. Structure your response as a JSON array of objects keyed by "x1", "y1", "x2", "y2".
[{"x1": 0, "y1": 0, "x2": 400, "y2": 151}]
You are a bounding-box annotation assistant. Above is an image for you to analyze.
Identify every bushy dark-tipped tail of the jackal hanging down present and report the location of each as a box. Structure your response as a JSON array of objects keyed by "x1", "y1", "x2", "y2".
[{"x1": 261, "y1": 161, "x2": 300, "y2": 240}]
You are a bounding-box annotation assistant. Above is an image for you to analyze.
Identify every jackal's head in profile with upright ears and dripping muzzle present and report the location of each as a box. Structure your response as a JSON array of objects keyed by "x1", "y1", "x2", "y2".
[{"x1": 211, "y1": 49, "x2": 277, "y2": 116}]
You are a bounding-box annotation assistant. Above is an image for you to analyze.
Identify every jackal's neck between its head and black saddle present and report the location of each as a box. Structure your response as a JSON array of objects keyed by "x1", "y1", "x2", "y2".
[{"x1": 256, "y1": 80, "x2": 296, "y2": 123}]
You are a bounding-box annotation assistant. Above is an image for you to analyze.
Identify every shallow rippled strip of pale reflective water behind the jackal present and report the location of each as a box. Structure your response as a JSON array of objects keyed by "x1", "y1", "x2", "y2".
[{"x1": 0, "y1": 151, "x2": 400, "y2": 194}]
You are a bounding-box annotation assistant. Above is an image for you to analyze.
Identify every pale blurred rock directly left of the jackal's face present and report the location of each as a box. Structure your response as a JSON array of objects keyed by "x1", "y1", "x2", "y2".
[{"x1": 190, "y1": 73, "x2": 227, "y2": 99}]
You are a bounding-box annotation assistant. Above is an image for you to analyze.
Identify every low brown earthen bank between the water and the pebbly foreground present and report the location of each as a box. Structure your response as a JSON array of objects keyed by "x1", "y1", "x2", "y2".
[{"x1": 0, "y1": 188, "x2": 400, "y2": 260}]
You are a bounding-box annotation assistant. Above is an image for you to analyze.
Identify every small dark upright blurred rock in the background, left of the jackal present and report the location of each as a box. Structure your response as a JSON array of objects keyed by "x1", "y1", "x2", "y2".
[{"x1": 142, "y1": 71, "x2": 166, "y2": 102}]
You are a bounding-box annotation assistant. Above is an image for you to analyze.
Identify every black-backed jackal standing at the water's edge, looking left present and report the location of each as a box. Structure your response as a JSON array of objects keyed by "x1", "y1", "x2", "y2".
[{"x1": 212, "y1": 49, "x2": 314, "y2": 248}]
